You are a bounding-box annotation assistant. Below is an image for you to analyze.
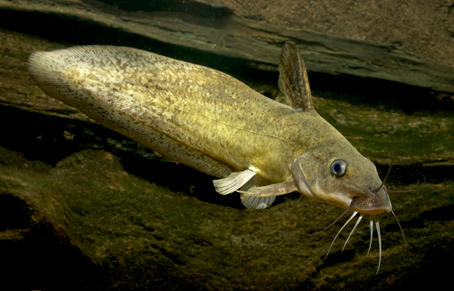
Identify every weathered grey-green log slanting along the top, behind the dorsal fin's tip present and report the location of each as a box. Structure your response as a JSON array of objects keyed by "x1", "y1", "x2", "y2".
[{"x1": 0, "y1": 0, "x2": 454, "y2": 95}]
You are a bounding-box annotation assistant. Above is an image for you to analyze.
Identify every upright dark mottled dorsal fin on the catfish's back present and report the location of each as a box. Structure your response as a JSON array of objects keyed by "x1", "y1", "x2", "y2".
[{"x1": 278, "y1": 42, "x2": 314, "y2": 111}]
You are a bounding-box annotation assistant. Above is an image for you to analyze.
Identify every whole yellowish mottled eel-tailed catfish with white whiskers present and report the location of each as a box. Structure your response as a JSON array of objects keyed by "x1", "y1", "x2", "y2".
[{"x1": 29, "y1": 43, "x2": 403, "y2": 274}]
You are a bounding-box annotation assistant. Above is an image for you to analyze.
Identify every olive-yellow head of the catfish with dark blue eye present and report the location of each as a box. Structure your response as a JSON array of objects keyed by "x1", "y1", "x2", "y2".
[{"x1": 291, "y1": 139, "x2": 392, "y2": 214}]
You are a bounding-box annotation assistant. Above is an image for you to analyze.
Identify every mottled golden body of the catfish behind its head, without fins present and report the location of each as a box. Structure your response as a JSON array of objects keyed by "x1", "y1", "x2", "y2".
[{"x1": 29, "y1": 46, "x2": 345, "y2": 182}]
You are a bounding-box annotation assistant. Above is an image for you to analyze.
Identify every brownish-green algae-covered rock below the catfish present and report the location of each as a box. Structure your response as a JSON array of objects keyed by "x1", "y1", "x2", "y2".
[{"x1": 0, "y1": 139, "x2": 454, "y2": 290}]
